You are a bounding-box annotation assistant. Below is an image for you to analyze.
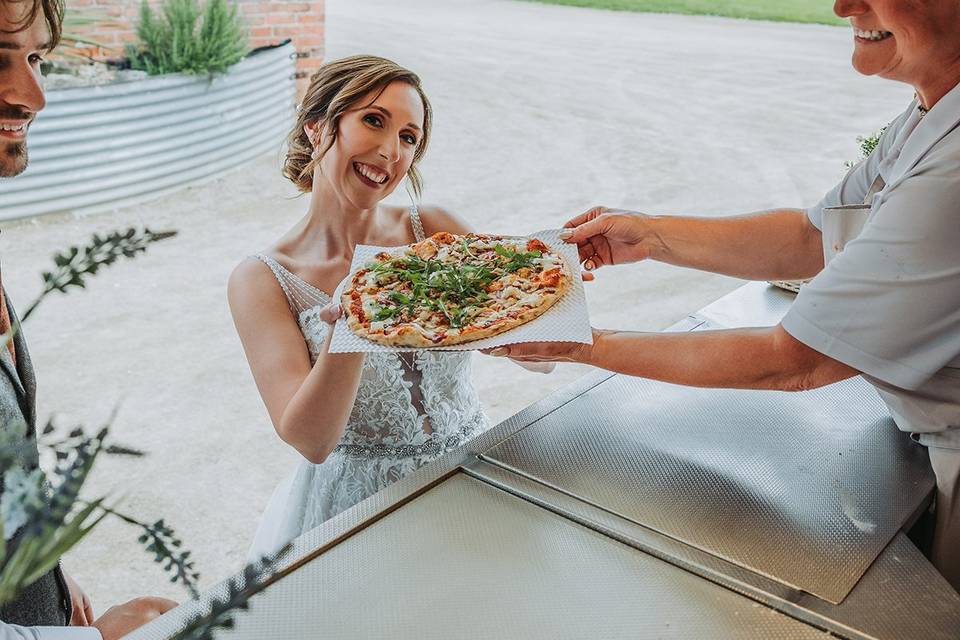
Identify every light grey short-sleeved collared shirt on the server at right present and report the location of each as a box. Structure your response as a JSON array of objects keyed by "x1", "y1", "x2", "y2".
[{"x1": 783, "y1": 80, "x2": 960, "y2": 449}]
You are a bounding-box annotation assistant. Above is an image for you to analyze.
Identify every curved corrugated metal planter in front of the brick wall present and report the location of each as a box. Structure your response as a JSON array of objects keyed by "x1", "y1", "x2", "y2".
[{"x1": 0, "y1": 43, "x2": 296, "y2": 220}]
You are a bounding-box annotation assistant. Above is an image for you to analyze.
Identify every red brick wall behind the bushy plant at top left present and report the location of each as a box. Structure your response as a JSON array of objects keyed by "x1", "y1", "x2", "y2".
[{"x1": 67, "y1": 0, "x2": 324, "y2": 85}]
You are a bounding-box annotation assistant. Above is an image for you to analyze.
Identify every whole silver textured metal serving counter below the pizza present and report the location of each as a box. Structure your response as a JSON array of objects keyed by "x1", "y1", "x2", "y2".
[{"x1": 130, "y1": 284, "x2": 960, "y2": 640}]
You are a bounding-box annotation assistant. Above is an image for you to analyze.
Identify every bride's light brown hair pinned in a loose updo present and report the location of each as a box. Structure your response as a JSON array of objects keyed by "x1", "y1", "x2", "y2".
[{"x1": 283, "y1": 56, "x2": 433, "y2": 197}]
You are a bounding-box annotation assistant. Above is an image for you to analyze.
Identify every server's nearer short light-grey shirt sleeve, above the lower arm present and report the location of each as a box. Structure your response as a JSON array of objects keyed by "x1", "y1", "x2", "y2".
[{"x1": 782, "y1": 149, "x2": 960, "y2": 389}]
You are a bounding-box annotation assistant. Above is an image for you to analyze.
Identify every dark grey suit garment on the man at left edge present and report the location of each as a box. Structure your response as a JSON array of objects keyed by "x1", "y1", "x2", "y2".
[{"x1": 0, "y1": 291, "x2": 70, "y2": 626}]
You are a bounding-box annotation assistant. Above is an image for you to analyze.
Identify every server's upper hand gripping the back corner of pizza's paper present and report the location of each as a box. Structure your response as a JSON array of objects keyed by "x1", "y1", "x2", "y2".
[{"x1": 561, "y1": 207, "x2": 656, "y2": 270}]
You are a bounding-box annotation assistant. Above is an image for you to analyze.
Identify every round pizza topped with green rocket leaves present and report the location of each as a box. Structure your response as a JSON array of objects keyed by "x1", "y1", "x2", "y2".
[{"x1": 340, "y1": 232, "x2": 572, "y2": 347}]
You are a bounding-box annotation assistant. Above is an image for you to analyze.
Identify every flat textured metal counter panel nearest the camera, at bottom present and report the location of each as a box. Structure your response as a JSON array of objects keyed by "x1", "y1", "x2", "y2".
[{"x1": 142, "y1": 474, "x2": 830, "y2": 640}]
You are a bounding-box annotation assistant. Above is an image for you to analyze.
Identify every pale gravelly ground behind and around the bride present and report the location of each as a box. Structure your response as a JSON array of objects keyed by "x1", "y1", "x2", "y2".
[{"x1": 0, "y1": 0, "x2": 910, "y2": 612}]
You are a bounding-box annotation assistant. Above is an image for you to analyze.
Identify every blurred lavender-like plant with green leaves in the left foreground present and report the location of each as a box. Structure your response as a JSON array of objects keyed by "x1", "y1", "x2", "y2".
[{"x1": 0, "y1": 229, "x2": 289, "y2": 640}]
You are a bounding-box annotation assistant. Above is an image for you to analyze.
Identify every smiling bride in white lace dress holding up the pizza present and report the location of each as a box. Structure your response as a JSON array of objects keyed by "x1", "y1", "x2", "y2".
[{"x1": 228, "y1": 56, "x2": 536, "y2": 557}]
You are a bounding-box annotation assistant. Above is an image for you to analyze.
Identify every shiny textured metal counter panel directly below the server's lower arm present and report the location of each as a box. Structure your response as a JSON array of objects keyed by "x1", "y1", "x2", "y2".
[{"x1": 482, "y1": 376, "x2": 933, "y2": 603}]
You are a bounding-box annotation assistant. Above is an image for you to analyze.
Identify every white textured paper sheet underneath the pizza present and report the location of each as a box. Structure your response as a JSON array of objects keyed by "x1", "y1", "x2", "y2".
[{"x1": 330, "y1": 229, "x2": 593, "y2": 353}]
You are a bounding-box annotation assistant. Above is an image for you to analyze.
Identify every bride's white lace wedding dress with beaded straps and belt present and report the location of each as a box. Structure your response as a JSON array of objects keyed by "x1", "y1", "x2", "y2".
[{"x1": 248, "y1": 208, "x2": 490, "y2": 560}]
